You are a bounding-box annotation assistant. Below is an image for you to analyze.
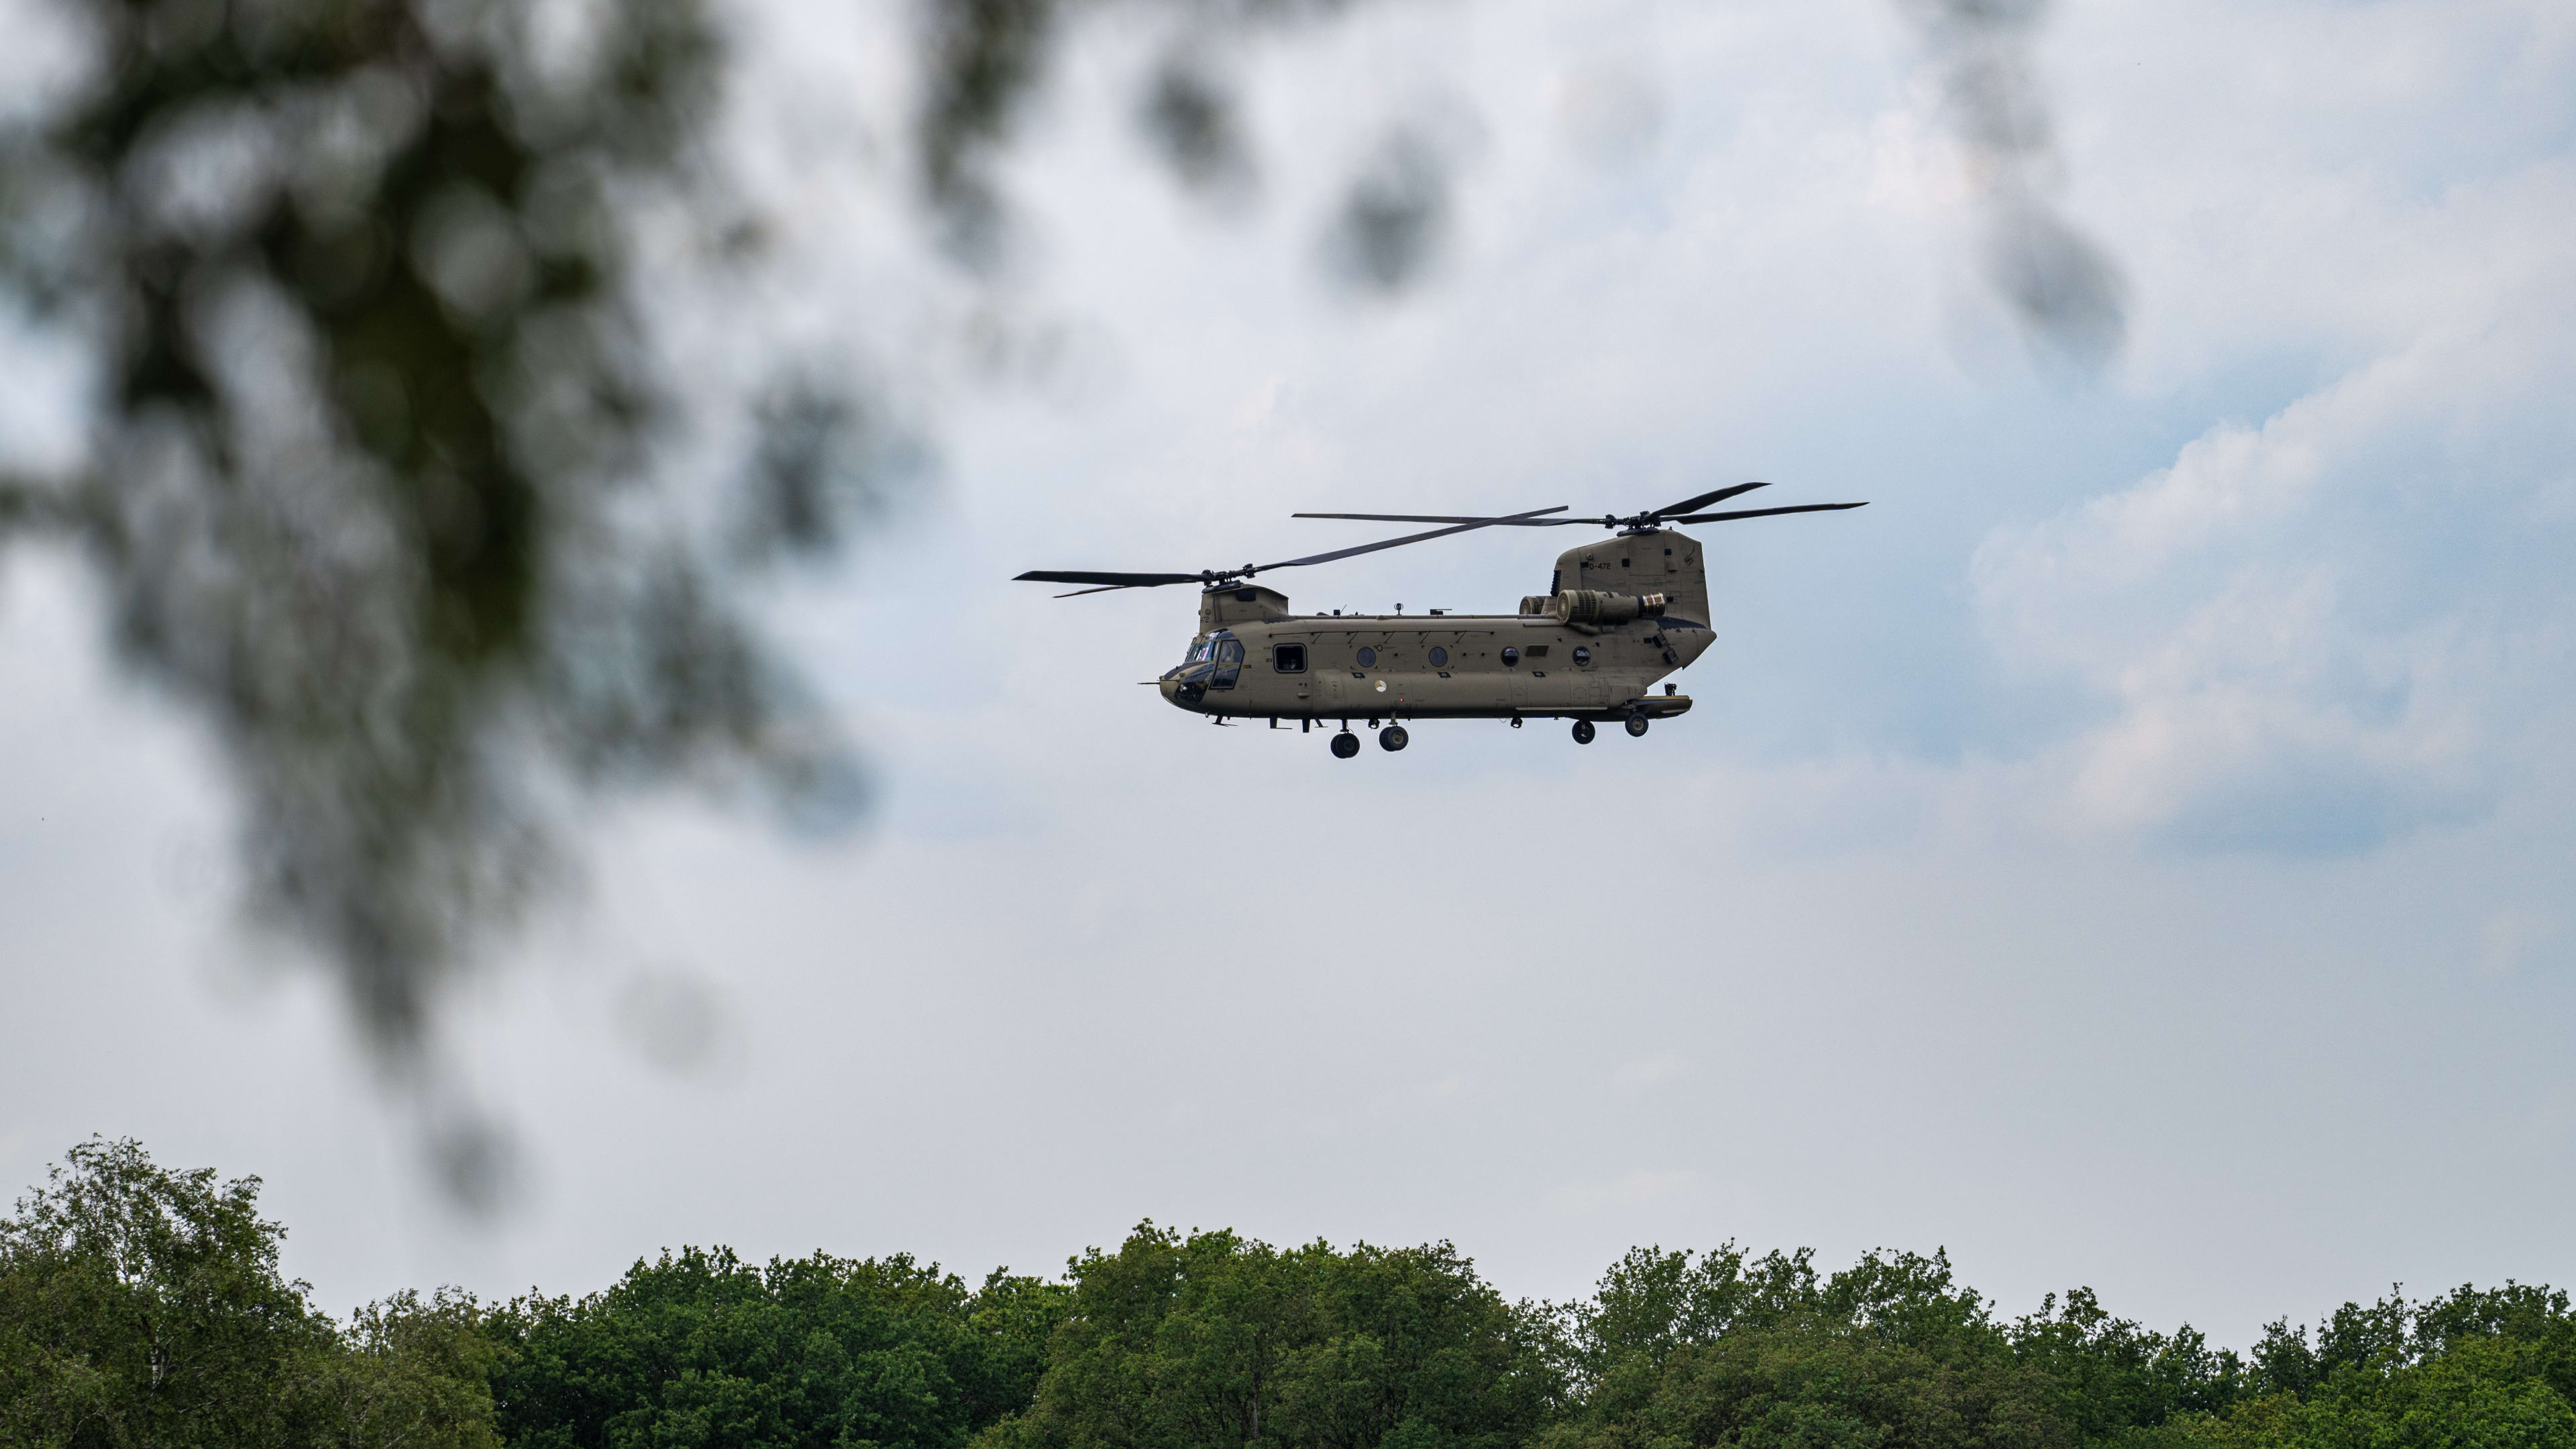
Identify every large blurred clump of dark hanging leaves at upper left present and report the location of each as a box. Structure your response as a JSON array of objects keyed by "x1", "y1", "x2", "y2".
[{"x1": 0, "y1": 0, "x2": 858, "y2": 1196}]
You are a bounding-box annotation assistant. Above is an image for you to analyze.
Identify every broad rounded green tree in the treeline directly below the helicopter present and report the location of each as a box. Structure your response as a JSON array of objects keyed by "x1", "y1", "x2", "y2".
[{"x1": 987, "y1": 1222, "x2": 1556, "y2": 1449}]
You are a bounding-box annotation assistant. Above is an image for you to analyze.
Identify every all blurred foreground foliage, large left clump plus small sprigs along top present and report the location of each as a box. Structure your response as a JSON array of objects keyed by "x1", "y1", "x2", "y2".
[{"x1": 0, "y1": 0, "x2": 2117, "y2": 1204}]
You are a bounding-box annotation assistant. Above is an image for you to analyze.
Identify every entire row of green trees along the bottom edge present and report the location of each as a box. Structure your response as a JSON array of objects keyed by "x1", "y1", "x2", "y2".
[{"x1": 0, "y1": 1142, "x2": 2576, "y2": 1449}]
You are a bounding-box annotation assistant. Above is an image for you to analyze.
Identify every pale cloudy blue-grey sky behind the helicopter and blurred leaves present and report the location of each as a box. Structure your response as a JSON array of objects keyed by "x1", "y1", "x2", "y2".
[{"x1": 0, "y1": 0, "x2": 2576, "y2": 1346}]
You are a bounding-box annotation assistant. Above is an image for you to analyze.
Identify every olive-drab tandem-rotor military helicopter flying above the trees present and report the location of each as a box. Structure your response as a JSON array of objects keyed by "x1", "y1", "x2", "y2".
[{"x1": 1018, "y1": 482, "x2": 1865, "y2": 761}]
